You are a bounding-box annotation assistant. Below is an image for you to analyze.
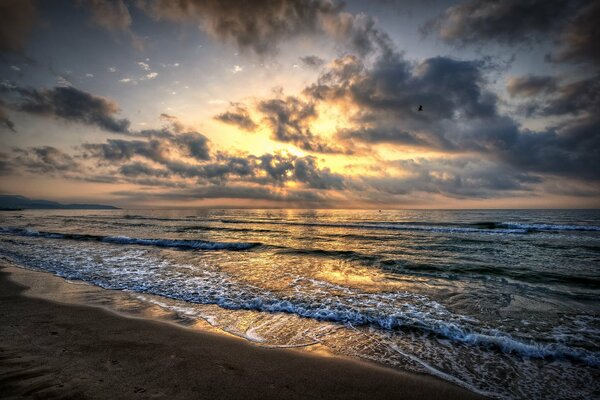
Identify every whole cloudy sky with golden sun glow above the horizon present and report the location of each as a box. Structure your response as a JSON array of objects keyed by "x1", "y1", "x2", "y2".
[{"x1": 0, "y1": 0, "x2": 600, "y2": 209}]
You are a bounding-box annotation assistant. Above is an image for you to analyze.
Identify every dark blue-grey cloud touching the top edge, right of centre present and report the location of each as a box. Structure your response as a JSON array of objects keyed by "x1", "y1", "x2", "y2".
[{"x1": 423, "y1": 0, "x2": 578, "y2": 44}]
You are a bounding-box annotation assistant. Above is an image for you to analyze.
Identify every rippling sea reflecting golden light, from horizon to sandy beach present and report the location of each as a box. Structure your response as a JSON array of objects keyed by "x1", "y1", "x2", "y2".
[{"x1": 0, "y1": 210, "x2": 600, "y2": 399}]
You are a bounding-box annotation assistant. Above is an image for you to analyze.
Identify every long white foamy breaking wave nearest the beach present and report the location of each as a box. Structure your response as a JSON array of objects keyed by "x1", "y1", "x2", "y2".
[{"x1": 4, "y1": 240, "x2": 600, "y2": 366}]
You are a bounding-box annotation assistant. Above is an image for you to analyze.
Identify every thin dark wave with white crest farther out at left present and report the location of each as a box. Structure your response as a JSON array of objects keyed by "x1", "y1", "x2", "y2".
[{"x1": 0, "y1": 227, "x2": 261, "y2": 250}]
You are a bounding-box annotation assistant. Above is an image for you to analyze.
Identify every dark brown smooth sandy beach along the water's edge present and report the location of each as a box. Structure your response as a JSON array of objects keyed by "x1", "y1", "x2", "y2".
[{"x1": 0, "y1": 261, "x2": 484, "y2": 399}]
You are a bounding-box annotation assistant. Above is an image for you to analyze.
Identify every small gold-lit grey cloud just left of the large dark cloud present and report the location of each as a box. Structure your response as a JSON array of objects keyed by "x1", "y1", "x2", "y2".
[{"x1": 258, "y1": 96, "x2": 347, "y2": 153}]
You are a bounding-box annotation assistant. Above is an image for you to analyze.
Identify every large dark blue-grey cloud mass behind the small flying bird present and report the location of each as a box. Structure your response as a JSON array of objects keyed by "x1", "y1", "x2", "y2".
[{"x1": 305, "y1": 55, "x2": 497, "y2": 151}]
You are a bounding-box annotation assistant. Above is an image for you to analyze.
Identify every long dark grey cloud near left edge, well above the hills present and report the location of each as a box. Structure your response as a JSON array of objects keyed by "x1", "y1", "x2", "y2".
[{"x1": 3, "y1": 86, "x2": 129, "y2": 133}]
